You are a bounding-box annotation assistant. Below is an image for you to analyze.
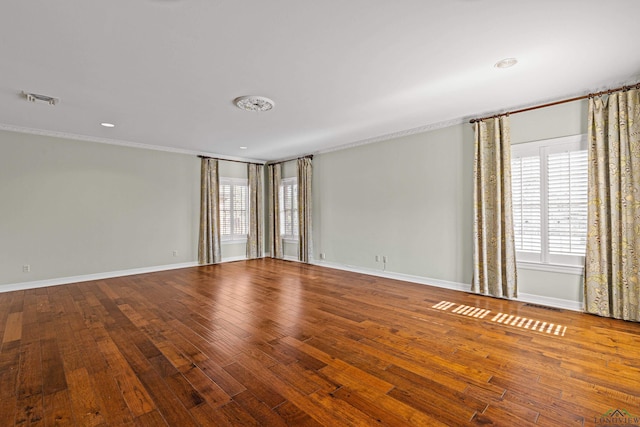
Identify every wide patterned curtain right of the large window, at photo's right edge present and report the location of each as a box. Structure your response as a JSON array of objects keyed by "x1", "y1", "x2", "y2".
[{"x1": 584, "y1": 89, "x2": 640, "y2": 322}]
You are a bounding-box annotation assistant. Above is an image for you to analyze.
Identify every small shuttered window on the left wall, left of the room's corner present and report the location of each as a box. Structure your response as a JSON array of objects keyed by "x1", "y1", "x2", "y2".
[{"x1": 220, "y1": 178, "x2": 249, "y2": 240}]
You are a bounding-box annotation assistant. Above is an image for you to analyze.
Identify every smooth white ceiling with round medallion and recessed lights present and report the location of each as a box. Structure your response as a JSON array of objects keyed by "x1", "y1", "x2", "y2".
[{"x1": 0, "y1": 0, "x2": 640, "y2": 160}]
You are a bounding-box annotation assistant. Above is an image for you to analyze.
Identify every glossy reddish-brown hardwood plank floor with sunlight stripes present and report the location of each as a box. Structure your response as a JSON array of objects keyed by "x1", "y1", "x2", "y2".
[{"x1": 0, "y1": 259, "x2": 640, "y2": 426}]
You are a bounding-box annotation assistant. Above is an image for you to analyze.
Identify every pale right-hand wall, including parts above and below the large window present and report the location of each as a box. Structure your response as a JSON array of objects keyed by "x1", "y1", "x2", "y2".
[{"x1": 313, "y1": 98, "x2": 586, "y2": 302}]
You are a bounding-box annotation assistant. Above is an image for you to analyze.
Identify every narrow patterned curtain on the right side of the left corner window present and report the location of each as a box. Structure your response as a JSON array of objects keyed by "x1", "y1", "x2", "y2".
[{"x1": 247, "y1": 163, "x2": 264, "y2": 259}]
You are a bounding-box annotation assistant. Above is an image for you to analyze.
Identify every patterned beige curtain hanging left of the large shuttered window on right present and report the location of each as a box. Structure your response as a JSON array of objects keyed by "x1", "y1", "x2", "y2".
[{"x1": 471, "y1": 116, "x2": 518, "y2": 298}]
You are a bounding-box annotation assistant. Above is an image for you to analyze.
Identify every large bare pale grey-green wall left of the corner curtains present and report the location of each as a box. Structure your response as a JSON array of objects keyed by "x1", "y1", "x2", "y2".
[{"x1": 0, "y1": 131, "x2": 200, "y2": 285}]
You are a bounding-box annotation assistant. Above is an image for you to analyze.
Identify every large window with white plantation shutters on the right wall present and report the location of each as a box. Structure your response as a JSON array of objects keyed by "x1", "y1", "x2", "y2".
[{"x1": 511, "y1": 136, "x2": 587, "y2": 266}]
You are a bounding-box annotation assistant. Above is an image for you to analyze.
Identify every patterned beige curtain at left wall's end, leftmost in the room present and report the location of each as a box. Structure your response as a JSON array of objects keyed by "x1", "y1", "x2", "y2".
[{"x1": 198, "y1": 158, "x2": 222, "y2": 264}]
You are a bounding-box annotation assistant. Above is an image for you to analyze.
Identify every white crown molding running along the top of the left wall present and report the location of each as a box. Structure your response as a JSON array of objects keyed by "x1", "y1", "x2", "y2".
[{"x1": 0, "y1": 123, "x2": 266, "y2": 164}]
